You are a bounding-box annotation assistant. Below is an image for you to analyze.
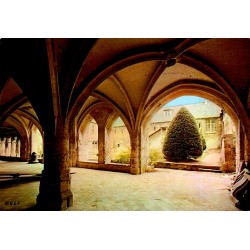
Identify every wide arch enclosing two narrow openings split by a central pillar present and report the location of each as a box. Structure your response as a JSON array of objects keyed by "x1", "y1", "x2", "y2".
[{"x1": 75, "y1": 98, "x2": 130, "y2": 173}]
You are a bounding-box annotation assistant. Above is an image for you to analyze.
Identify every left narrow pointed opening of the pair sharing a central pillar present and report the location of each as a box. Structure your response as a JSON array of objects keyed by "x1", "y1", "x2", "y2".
[{"x1": 78, "y1": 114, "x2": 98, "y2": 162}]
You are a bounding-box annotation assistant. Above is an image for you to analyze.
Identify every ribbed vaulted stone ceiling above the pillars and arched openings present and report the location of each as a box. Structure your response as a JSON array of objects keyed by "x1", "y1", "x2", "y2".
[{"x1": 0, "y1": 38, "x2": 250, "y2": 138}]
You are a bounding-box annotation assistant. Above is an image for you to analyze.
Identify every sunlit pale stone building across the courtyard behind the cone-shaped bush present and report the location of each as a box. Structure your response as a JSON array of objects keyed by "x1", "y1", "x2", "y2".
[{"x1": 113, "y1": 100, "x2": 236, "y2": 162}]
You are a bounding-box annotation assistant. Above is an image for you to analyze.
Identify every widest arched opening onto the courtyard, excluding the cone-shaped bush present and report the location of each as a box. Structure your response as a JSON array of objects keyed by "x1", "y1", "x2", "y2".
[{"x1": 143, "y1": 90, "x2": 240, "y2": 172}]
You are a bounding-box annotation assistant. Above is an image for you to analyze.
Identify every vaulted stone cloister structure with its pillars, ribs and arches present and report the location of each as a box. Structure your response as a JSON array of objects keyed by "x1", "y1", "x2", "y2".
[{"x1": 0, "y1": 38, "x2": 250, "y2": 210}]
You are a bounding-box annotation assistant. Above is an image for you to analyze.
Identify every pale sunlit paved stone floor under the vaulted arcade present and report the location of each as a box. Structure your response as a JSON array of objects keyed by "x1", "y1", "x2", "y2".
[{"x1": 0, "y1": 161, "x2": 239, "y2": 211}]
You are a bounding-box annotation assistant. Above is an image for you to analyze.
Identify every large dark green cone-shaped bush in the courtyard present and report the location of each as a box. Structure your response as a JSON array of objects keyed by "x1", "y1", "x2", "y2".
[{"x1": 162, "y1": 107, "x2": 203, "y2": 161}]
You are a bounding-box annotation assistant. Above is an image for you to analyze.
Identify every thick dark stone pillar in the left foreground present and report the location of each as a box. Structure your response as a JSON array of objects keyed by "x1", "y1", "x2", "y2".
[{"x1": 37, "y1": 122, "x2": 73, "y2": 211}]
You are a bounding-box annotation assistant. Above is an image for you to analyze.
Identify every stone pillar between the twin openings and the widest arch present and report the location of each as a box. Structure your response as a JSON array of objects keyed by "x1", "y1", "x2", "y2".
[{"x1": 130, "y1": 131, "x2": 141, "y2": 174}]
